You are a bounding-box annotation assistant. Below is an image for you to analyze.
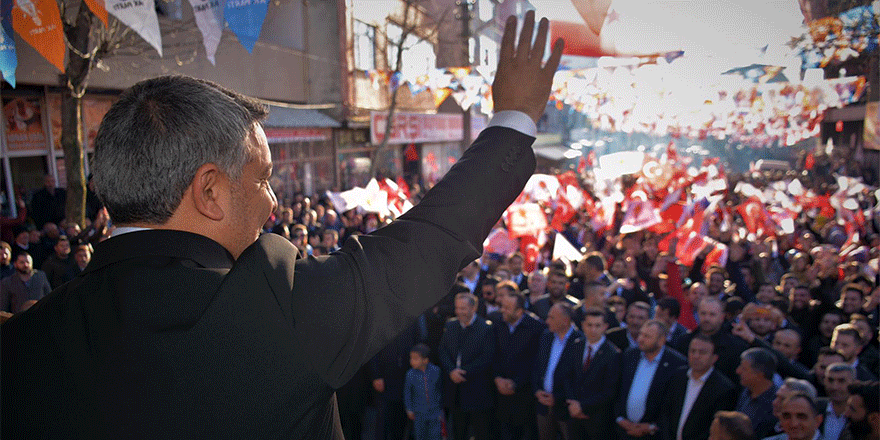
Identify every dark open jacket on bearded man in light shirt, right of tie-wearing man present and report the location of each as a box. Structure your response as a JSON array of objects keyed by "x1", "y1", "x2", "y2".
[{"x1": 614, "y1": 347, "x2": 687, "y2": 428}]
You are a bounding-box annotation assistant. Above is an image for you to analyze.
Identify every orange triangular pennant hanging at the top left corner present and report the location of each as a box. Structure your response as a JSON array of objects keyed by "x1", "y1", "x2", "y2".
[{"x1": 7, "y1": 0, "x2": 64, "y2": 72}]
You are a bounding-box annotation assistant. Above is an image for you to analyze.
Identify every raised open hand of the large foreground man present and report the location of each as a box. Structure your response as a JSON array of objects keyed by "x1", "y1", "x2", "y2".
[{"x1": 492, "y1": 11, "x2": 564, "y2": 123}]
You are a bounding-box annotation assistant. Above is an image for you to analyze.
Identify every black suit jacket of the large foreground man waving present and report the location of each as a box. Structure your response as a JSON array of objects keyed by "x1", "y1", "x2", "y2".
[{"x1": 0, "y1": 127, "x2": 535, "y2": 439}]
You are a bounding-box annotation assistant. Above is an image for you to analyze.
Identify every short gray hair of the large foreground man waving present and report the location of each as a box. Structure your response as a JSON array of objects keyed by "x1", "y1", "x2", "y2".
[{"x1": 92, "y1": 76, "x2": 267, "y2": 224}]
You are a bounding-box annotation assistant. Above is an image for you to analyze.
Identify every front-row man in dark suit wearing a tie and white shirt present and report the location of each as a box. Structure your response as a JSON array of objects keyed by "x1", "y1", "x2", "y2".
[{"x1": 566, "y1": 307, "x2": 620, "y2": 440}]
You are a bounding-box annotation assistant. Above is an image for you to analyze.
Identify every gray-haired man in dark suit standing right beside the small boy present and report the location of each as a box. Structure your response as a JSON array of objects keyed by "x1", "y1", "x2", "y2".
[{"x1": 439, "y1": 293, "x2": 495, "y2": 440}]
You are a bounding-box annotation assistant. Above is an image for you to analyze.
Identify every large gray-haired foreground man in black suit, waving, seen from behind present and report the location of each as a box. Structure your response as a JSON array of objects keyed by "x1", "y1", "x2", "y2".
[{"x1": 0, "y1": 11, "x2": 562, "y2": 439}]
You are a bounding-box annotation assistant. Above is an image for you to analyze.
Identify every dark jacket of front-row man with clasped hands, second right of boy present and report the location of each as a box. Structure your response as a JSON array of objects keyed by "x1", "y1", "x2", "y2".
[{"x1": 492, "y1": 312, "x2": 547, "y2": 424}]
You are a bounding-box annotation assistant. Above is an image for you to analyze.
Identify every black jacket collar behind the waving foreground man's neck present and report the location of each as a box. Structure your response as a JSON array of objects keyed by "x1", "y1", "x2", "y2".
[{"x1": 83, "y1": 229, "x2": 235, "y2": 274}]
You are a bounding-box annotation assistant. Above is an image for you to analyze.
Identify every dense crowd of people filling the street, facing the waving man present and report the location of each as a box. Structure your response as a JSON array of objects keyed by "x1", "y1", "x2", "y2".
[{"x1": 0, "y1": 148, "x2": 880, "y2": 440}]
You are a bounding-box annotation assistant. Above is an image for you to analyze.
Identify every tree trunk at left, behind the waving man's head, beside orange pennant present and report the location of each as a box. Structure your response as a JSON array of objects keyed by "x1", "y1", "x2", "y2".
[{"x1": 61, "y1": 3, "x2": 92, "y2": 228}]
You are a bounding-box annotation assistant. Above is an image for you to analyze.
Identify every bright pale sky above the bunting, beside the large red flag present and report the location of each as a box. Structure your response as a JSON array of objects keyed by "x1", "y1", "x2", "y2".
[{"x1": 530, "y1": 0, "x2": 803, "y2": 77}]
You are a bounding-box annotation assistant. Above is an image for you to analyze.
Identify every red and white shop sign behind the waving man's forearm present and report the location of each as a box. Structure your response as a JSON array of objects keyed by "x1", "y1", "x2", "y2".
[{"x1": 370, "y1": 112, "x2": 462, "y2": 144}]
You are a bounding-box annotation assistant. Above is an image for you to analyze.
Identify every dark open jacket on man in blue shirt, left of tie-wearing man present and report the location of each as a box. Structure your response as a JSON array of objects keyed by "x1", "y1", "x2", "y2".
[{"x1": 532, "y1": 329, "x2": 584, "y2": 420}]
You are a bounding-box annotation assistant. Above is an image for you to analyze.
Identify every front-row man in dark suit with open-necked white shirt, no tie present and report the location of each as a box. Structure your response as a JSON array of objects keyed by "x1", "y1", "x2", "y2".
[{"x1": 659, "y1": 335, "x2": 737, "y2": 440}]
